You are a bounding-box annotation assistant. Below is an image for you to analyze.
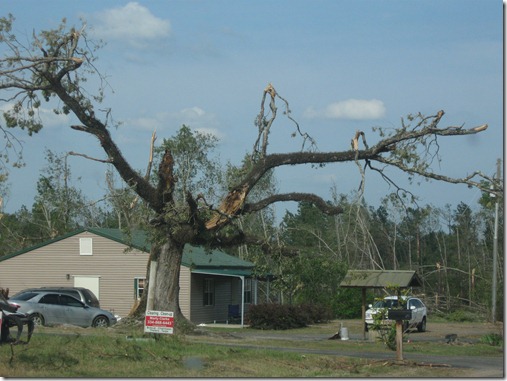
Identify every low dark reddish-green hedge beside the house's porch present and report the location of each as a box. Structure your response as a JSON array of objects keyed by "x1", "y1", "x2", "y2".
[{"x1": 245, "y1": 303, "x2": 331, "y2": 330}]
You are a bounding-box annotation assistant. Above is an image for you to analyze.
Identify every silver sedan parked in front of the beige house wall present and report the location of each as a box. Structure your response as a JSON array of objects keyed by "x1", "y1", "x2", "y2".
[{"x1": 9, "y1": 292, "x2": 116, "y2": 327}]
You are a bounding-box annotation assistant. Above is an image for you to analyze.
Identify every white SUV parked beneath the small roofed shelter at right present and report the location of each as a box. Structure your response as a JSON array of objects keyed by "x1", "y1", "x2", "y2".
[{"x1": 365, "y1": 296, "x2": 428, "y2": 332}]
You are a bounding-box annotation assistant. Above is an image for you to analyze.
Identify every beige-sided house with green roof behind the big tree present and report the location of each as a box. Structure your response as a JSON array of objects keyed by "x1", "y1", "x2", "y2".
[{"x1": 0, "y1": 228, "x2": 257, "y2": 324}]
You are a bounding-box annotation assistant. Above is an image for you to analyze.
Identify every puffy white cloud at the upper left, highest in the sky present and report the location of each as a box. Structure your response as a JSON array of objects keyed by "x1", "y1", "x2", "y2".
[{"x1": 94, "y1": 2, "x2": 171, "y2": 47}]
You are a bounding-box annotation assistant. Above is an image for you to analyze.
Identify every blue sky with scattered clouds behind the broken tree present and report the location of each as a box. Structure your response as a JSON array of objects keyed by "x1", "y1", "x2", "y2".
[{"x1": 1, "y1": 0, "x2": 503, "y2": 221}]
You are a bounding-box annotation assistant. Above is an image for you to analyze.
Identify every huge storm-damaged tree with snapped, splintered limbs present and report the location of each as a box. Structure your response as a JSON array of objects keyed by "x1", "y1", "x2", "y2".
[{"x1": 0, "y1": 16, "x2": 502, "y2": 324}]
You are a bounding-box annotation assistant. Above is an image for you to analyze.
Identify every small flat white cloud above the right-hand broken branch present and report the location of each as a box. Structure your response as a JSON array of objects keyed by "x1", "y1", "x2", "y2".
[{"x1": 304, "y1": 99, "x2": 386, "y2": 120}]
